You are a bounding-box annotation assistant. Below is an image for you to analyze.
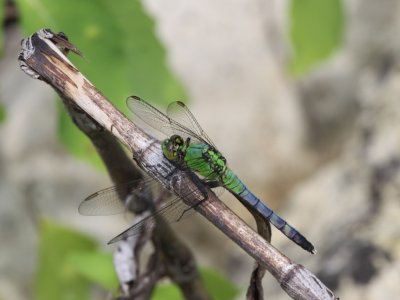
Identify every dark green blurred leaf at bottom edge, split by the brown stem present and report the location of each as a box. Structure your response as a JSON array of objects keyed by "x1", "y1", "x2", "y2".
[{"x1": 151, "y1": 268, "x2": 240, "y2": 300}]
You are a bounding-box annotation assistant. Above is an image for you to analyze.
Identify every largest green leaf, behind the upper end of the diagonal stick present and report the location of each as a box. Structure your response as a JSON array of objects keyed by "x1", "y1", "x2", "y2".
[{"x1": 16, "y1": 0, "x2": 185, "y2": 169}]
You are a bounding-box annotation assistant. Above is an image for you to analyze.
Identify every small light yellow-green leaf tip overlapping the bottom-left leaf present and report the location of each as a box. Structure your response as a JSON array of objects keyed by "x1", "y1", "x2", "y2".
[{"x1": 68, "y1": 251, "x2": 119, "y2": 291}]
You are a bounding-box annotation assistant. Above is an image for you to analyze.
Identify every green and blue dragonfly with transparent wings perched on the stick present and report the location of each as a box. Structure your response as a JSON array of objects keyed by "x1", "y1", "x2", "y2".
[{"x1": 80, "y1": 96, "x2": 316, "y2": 253}]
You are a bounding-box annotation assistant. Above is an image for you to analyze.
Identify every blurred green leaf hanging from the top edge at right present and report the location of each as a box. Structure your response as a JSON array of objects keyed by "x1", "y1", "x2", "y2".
[{"x1": 290, "y1": 0, "x2": 345, "y2": 75}]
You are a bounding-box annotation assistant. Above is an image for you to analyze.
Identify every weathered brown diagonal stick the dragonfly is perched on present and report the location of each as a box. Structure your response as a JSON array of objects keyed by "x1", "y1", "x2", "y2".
[{"x1": 19, "y1": 30, "x2": 335, "y2": 300}]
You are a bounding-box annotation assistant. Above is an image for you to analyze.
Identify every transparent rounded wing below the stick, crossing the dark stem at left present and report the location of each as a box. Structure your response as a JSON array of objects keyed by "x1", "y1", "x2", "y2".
[{"x1": 78, "y1": 177, "x2": 159, "y2": 216}]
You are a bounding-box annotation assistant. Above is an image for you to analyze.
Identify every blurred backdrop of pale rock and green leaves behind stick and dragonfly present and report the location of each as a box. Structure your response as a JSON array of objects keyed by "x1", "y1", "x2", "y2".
[{"x1": 0, "y1": 0, "x2": 400, "y2": 300}]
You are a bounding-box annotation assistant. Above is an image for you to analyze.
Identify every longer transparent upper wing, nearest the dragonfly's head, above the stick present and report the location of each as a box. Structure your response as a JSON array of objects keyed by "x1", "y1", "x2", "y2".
[{"x1": 126, "y1": 96, "x2": 209, "y2": 143}]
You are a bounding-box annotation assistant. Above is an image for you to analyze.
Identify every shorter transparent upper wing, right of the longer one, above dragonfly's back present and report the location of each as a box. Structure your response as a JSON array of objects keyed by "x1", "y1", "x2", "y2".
[{"x1": 167, "y1": 101, "x2": 216, "y2": 148}]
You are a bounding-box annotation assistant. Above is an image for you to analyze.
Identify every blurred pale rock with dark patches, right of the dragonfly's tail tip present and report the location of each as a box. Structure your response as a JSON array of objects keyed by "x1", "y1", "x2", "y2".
[{"x1": 278, "y1": 55, "x2": 400, "y2": 300}]
